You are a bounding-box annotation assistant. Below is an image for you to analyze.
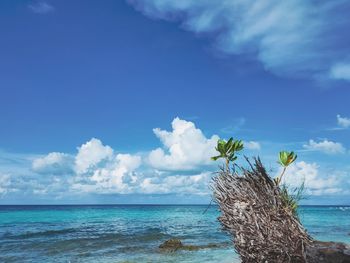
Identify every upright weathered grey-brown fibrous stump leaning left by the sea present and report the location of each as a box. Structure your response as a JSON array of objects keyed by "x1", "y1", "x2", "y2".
[{"x1": 212, "y1": 159, "x2": 312, "y2": 263}]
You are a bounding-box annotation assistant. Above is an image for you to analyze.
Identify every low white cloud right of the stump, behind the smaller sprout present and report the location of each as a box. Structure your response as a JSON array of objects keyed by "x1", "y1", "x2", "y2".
[{"x1": 279, "y1": 161, "x2": 341, "y2": 195}]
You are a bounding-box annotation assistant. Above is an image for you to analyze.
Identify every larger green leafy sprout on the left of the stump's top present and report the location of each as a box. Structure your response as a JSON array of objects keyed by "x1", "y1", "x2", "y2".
[{"x1": 211, "y1": 137, "x2": 243, "y2": 171}]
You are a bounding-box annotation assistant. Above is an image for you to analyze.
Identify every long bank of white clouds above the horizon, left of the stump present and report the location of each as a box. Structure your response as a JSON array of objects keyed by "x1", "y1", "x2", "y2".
[{"x1": 0, "y1": 118, "x2": 219, "y2": 197}]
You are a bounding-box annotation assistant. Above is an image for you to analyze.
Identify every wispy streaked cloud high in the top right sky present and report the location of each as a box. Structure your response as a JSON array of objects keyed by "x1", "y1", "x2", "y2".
[{"x1": 128, "y1": 0, "x2": 350, "y2": 80}]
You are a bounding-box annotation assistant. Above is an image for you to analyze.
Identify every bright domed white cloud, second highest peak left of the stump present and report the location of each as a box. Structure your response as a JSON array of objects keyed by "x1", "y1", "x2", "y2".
[{"x1": 75, "y1": 138, "x2": 113, "y2": 173}]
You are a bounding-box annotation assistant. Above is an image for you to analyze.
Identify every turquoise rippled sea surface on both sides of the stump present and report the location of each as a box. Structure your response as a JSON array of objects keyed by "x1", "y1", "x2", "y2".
[{"x1": 0, "y1": 205, "x2": 350, "y2": 263}]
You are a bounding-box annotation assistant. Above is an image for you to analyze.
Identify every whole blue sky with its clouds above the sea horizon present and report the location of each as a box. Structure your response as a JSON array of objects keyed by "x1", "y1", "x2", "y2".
[{"x1": 0, "y1": 0, "x2": 350, "y2": 205}]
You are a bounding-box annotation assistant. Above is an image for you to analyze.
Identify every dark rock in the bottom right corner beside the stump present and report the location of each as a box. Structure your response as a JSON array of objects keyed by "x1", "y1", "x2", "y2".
[{"x1": 306, "y1": 241, "x2": 350, "y2": 263}]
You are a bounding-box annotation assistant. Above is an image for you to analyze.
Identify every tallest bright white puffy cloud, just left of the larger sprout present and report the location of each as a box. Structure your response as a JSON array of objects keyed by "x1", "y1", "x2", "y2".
[{"x1": 148, "y1": 118, "x2": 219, "y2": 170}]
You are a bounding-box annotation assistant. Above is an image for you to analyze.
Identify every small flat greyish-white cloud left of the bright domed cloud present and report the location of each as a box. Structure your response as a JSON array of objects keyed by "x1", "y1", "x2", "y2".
[{"x1": 32, "y1": 152, "x2": 74, "y2": 174}]
